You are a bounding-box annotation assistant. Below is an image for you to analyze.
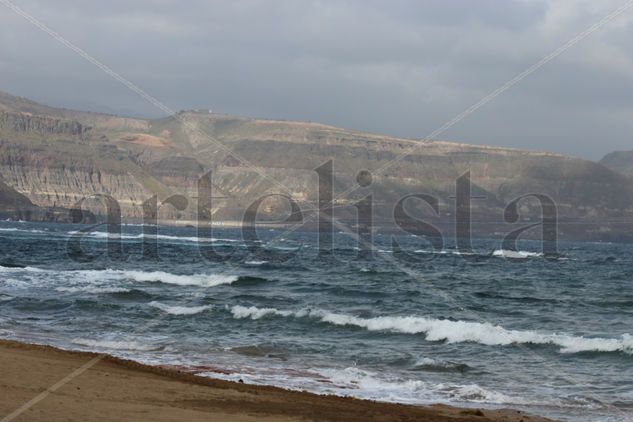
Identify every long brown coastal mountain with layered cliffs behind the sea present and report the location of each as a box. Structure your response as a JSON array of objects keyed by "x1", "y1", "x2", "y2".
[{"x1": 0, "y1": 90, "x2": 633, "y2": 237}]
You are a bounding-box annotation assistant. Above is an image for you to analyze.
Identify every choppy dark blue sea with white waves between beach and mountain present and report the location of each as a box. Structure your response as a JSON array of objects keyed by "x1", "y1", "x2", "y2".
[{"x1": 0, "y1": 222, "x2": 633, "y2": 421}]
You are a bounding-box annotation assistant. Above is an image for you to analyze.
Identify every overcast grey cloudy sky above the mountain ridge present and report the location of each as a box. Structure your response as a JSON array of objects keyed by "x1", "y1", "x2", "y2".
[{"x1": 0, "y1": 0, "x2": 633, "y2": 160}]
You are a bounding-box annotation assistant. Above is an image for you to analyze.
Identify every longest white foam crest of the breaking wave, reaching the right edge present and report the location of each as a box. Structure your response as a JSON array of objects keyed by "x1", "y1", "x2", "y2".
[{"x1": 231, "y1": 306, "x2": 633, "y2": 355}]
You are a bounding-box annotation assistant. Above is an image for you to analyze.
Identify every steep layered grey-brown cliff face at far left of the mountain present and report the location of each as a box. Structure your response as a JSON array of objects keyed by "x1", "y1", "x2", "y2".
[{"x1": 0, "y1": 111, "x2": 180, "y2": 218}]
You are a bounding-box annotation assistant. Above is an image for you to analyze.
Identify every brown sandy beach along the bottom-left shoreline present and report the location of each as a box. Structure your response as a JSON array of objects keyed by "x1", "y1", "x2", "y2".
[{"x1": 0, "y1": 341, "x2": 546, "y2": 422}]
